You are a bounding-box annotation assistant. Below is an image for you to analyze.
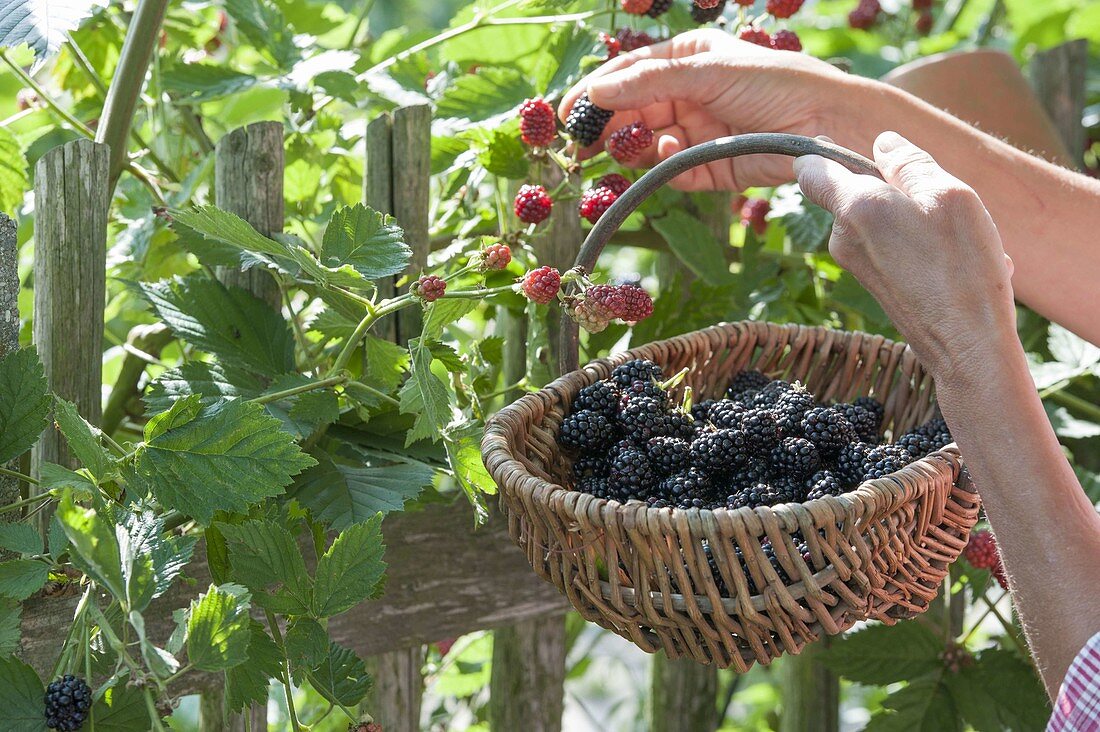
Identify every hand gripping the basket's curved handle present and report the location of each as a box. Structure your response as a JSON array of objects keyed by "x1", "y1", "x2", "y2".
[{"x1": 794, "y1": 132, "x2": 1022, "y2": 381}]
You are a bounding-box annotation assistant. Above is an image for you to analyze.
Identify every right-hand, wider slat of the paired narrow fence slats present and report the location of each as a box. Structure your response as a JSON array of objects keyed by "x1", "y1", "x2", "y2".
[{"x1": 393, "y1": 105, "x2": 431, "y2": 343}]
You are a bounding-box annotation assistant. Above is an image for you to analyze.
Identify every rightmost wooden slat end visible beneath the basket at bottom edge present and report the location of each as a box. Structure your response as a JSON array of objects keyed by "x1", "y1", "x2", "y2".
[{"x1": 778, "y1": 636, "x2": 840, "y2": 732}]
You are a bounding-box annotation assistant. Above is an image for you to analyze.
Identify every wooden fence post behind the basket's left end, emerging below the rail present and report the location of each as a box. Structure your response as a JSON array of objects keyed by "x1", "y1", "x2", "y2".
[{"x1": 488, "y1": 158, "x2": 584, "y2": 732}]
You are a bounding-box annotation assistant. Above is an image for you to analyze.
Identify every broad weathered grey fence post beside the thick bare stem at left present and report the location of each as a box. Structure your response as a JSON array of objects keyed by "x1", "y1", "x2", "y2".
[{"x1": 32, "y1": 140, "x2": 110, "y2": 517}]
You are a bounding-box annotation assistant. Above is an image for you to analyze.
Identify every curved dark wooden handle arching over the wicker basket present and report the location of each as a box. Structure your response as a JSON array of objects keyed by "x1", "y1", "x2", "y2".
[{"x1": 560, "y1": 132, "x2": 882, "y2": 374}]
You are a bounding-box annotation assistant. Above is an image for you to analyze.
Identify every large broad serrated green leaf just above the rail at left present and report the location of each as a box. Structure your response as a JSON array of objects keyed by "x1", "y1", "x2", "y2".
[{"x1": 124, "y1": 400, "x2": 316, "y2": 525}]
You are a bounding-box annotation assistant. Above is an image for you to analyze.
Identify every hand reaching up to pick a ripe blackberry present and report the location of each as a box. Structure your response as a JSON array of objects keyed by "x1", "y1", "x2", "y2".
[{"x1": 559, "y1": 30, "x2": 861, "y2": 190}]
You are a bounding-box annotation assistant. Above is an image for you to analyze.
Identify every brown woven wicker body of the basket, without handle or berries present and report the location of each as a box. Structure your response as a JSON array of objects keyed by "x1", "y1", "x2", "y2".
[{"x1": 482, "y1": 323, "x2": 979, "y2": 671}]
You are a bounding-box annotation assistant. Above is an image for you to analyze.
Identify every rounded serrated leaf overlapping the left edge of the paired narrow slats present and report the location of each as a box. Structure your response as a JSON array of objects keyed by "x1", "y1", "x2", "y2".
[{"x1": 320, "y1": 204, "x2": 413, "y2": 280}]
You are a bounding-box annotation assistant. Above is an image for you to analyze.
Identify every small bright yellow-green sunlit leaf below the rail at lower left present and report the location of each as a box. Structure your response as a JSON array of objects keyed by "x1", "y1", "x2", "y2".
[{"x1": 187, "y1": 584, "x2": 252, "y2": 671}]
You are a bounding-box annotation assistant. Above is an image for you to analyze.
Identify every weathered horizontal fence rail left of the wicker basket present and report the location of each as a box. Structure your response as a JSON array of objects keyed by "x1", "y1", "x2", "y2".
[{"x1": 20, "y1": 499, "x2": 567, "y2": 692}]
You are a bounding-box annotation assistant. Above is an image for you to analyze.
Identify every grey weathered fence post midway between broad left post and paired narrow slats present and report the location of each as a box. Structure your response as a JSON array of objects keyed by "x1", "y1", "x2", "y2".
[{"x1": 200, "y1": 122, "x2": 286, "y2": 732}]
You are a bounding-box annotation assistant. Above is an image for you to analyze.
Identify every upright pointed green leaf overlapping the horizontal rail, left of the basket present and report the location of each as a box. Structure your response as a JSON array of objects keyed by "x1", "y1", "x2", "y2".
[{"x1": 314, "y1": 514, "x2": 386, "y2": 618}]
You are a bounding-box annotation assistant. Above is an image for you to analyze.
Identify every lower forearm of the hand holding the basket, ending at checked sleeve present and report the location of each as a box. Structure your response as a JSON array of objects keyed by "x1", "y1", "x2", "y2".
[{"x1": 936, "y1": 343, "x2": 1100, "y2": 697}]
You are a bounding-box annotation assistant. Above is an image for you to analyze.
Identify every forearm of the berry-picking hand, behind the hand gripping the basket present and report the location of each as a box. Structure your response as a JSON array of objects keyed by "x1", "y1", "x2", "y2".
[{"x1": 826, "y1": 78, "x2": 1100, "y2": 343}]
